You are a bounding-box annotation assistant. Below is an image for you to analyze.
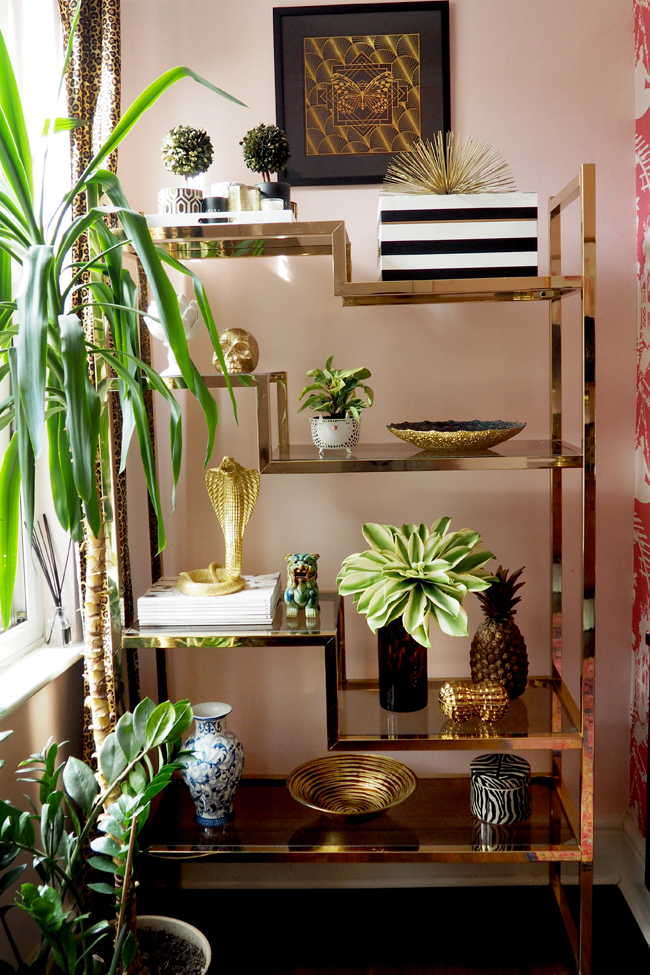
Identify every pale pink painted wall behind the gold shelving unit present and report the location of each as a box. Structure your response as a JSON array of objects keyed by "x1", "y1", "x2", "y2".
[{"x1": 120, "y1": 0, "x2": 635, "y2": 814}]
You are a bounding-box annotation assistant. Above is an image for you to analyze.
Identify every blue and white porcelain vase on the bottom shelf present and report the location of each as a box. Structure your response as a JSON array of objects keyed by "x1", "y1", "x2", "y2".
[{"x1": 183, "y1": 701, "x2": 244, "y2": 826}]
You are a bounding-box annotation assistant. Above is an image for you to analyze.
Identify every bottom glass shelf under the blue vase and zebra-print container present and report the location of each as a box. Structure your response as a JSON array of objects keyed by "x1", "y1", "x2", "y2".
[{"x1": 141, "y1": 776, "x2": 581, "y2": 874}]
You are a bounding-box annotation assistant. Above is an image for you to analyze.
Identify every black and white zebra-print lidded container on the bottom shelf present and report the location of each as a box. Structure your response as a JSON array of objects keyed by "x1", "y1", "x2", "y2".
[{"x1": 469, "y1": 752, "x2": 530, "y2": 826}]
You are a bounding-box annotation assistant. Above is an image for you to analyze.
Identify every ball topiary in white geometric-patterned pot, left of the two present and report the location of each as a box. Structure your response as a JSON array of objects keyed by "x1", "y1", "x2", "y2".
[{"x1": 158, "y1": 125, "x2": 214, "y2": 213}]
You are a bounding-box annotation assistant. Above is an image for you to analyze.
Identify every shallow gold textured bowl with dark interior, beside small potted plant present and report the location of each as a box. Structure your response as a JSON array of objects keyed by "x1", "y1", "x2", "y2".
[{"x1": 388, "y1": 420, "x2": 526, "y2": 453}]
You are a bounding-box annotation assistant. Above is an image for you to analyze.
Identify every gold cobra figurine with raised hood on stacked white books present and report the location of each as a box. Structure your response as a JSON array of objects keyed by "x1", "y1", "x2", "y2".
[{"x1": 178, "y1": 457, "x2": 260, "y2": 596}]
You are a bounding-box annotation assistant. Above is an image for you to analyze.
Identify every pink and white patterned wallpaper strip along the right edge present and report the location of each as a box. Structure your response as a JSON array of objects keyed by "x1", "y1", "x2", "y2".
[{"x1": 630, "y1": 0, "x2": 650, "y2": 836}]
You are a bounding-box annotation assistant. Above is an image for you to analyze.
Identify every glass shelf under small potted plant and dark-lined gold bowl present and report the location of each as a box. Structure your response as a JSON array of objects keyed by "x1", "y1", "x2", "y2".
[{"x1": 262, "y1": 437, "x2": 582, "y2": 474}]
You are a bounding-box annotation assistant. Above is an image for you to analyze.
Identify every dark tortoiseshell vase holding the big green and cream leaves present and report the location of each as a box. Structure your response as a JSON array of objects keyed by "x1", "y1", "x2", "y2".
[{"x1": 377, "y1": 619, "x2": 428, "y2": 711}]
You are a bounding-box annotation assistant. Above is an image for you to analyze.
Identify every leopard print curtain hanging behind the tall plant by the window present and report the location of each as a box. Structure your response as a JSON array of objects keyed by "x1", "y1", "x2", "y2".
[{"x1": 59, "y1": 0, "x2": 130, "y2": 761}]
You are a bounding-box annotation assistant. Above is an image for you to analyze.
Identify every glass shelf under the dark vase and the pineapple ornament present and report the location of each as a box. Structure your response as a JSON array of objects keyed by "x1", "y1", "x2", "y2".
[{"x1": 330, "y1": 677, "x2": 582, "y2": 751}]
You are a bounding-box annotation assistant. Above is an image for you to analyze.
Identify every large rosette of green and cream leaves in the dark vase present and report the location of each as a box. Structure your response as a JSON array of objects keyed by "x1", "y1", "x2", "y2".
[{"x1": 336, "y1": 517, "x2": 495, "y2": 647}]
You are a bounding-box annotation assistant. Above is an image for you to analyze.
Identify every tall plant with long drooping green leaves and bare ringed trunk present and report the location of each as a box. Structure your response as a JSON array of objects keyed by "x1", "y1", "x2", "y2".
[{"x1": 0, "y1": 9, "x2": 243, "y2": 764}]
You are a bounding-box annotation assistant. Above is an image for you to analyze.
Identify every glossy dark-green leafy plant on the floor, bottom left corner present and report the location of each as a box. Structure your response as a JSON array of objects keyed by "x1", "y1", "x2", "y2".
[{"x1": 0, "y1": 698, "x2": 210, "y2": 975}]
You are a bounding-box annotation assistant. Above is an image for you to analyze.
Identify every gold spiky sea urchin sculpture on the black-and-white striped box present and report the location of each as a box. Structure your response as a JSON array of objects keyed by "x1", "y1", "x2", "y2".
[{"x1": 384, "y1": 132, "x2": 515, "y2": 194}]
